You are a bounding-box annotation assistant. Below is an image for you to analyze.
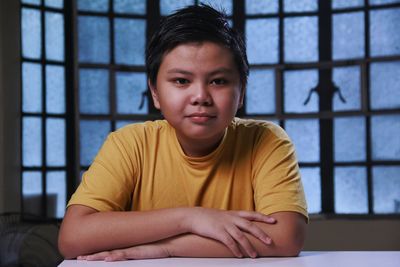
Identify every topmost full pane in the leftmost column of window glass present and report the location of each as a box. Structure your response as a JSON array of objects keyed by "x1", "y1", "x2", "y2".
[{"x1": 21, "y1": 8, "x2": 42, "y2": 59}]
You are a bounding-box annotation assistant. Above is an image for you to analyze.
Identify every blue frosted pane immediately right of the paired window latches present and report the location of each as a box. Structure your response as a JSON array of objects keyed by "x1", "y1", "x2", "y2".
[{"x1": 333, "y1": 66, "x2": 361, "y2": 111}]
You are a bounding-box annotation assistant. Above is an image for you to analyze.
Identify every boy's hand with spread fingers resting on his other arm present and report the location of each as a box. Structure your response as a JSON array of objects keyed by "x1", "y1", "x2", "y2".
[{"x1": 184, "y1": 207, "x2": 276, "y2": 258}]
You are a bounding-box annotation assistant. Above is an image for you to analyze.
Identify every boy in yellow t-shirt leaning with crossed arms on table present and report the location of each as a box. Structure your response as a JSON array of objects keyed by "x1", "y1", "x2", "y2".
[{"x1": 59, "y1": 6, "x2": 307, "y2": 261}]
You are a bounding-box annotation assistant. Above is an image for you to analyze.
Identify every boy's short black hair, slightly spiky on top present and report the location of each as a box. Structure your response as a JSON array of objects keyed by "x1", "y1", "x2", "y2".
[{"x1": 146, "y1": 4, "x2": 249, "y2": 90}]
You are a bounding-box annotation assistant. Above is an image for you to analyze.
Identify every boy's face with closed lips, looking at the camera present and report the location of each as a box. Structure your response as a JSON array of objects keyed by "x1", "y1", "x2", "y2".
[{"x1": 149, "y1": 42, "x2": 243, "y2": 151}]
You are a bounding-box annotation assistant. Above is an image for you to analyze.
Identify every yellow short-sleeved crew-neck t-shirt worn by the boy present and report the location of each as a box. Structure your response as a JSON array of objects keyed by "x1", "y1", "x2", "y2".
[{"x1": 68, "y1": 118, "x2": 308, "y2": 220}]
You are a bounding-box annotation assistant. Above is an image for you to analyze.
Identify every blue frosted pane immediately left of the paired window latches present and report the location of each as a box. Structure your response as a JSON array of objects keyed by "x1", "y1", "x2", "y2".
[{"x1": 284, "y1": 70, "x2": 318, "y2": 113}]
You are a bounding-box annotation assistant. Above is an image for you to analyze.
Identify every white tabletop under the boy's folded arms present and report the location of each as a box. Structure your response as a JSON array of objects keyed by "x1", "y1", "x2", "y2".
[{"x1": 59, "y1": 251, "x2": 400, "y2": 267}]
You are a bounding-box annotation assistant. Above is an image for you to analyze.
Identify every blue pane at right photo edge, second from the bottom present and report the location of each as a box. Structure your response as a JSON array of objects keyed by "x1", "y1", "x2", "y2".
[{"x1": 371, "y1": 115, "x2": 400, "y2": 160}]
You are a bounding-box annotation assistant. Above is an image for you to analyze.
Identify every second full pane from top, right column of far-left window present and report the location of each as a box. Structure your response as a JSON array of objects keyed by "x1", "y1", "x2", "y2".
[{"x1": 46, "y1": 65, "x2": 65, "y2": 114}]
